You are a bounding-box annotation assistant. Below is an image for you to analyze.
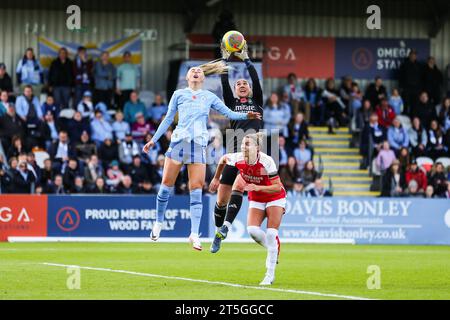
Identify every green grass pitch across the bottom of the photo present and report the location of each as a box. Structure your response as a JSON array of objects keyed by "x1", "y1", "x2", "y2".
[{"x1": 0, "y1": 242, "x2": 450, "y2": 300}]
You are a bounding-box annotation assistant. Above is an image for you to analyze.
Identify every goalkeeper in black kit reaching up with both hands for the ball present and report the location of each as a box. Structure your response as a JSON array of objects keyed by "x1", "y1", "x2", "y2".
[{"x1": 211, "y1": 43, "x2": 263, "y2": 253}]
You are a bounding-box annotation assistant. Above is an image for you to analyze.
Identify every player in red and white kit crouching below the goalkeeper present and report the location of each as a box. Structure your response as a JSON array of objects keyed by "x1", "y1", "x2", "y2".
[{"x1": 209, "y1": 133, "x2": 286, "y2": 285}]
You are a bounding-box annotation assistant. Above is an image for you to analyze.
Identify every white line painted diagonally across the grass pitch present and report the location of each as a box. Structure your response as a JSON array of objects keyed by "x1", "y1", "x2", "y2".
[{"x1": 40, "y1": 262, "x2": 376, "y2": 300}]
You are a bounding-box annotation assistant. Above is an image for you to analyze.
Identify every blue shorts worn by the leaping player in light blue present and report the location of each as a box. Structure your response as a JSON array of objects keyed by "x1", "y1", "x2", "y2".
[{"x1": 166, "y1": 140, "x2": 206, "y2": 164}]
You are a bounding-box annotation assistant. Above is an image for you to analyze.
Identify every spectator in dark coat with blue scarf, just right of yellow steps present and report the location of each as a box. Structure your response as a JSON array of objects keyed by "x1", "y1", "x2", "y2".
[{"x1": 359, "y1": 113, "x2": 387, "y2": 168}]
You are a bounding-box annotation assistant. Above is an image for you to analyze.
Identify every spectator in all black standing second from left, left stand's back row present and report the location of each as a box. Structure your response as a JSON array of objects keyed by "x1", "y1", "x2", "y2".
[{"x1": 48, "y1": 48, "x2": 75, "y2": 109}]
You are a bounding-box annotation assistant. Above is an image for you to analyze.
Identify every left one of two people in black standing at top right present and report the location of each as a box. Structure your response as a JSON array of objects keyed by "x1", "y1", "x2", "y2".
[{"x1": 399, "y1": 49, "x2": 424, "y2": 115}]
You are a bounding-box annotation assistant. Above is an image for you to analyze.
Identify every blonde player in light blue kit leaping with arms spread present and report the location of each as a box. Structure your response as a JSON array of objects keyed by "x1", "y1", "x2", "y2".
[{"x1": 143, "y1": 61, "x2": 261, "y2": 250}]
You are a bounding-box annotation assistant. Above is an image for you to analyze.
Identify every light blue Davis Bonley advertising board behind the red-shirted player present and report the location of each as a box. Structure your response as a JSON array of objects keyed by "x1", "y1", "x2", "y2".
[{"x1": 210, "y1": 196, "x2": 450, "y2": 245}]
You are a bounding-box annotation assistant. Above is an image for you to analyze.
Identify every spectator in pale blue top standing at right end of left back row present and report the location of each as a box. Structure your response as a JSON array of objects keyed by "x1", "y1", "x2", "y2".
[{"x1": 116, "y1": 51, "x2": 141, "y2": 110}]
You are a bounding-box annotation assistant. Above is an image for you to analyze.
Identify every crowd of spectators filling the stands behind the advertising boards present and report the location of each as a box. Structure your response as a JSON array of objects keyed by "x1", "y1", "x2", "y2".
[{"x1": 0, "y1": 47, "x2": 450, "y2": 198}]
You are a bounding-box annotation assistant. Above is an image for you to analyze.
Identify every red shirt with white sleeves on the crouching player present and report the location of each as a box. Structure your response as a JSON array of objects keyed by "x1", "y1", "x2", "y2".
[{"x1": 226, "y1": 152, "x2": 286, "y2": 203}]
